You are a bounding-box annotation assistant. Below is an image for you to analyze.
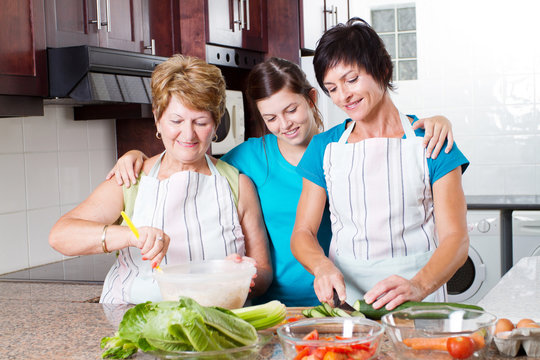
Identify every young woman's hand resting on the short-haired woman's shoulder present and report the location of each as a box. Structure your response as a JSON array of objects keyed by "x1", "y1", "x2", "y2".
[{"x1": 412, "y1": 116, "x2": 454, "y2": 159}]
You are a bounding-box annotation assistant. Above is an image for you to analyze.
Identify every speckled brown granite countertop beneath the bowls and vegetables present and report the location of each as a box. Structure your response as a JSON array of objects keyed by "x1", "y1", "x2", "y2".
[{"x1": 0, "y1": 281, "x2": 527, "y2": 360}]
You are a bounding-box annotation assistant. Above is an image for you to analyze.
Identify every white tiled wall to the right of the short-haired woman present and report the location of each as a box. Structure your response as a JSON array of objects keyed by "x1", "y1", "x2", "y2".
[{"x1": 350, "y1": 0, "x2": 540, "y2": 195}]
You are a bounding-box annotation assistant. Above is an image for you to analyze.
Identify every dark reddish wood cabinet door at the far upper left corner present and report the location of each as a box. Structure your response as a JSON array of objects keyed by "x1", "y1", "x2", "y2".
[{"x1": 0, "y1": 0, "x2": 48, "y2": 96}]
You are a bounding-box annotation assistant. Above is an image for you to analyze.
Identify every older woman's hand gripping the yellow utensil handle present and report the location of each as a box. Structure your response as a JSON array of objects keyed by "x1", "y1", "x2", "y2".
[{"x1": 132, "y1": 226, "x2": 171, "y2": 269}]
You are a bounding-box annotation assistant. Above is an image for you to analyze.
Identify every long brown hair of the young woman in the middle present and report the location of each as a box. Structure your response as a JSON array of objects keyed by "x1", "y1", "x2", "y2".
[{"x1": 246, "y1": 57, "x2": 323, "y2": 135}]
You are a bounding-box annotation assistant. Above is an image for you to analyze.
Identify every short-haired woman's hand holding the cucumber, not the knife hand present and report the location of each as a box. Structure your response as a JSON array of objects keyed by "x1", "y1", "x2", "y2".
[{"x1": 364, "y1": 275, "x2": 427, "y2": 310}]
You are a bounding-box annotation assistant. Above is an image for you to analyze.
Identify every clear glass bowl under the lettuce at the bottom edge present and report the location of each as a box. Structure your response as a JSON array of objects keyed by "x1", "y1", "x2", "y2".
[{"x1": 147, "y1": 333, "x2": 274, "y2": 360}]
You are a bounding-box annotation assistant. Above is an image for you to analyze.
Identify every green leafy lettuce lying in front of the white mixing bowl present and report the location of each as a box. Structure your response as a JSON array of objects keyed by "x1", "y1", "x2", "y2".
[{"x1": 101, "y1": 298, "x2": 258, "y2": 359}]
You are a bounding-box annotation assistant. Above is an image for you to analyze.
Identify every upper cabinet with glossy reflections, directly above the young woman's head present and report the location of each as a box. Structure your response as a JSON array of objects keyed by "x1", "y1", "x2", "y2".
[{"x1": 206, "y1": 0, "x2": 268, "y2": 52}]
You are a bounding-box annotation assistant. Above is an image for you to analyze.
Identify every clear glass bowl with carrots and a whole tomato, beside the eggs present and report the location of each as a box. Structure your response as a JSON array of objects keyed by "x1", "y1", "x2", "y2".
[{"x1": 381, "y1": 305, "x2": 497, "y2": 360}]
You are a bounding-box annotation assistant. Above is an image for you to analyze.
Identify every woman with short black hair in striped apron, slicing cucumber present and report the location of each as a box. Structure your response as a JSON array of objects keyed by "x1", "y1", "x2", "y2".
[{"x1": 291, "y1": 18, "x2": 469, "y2": 310}]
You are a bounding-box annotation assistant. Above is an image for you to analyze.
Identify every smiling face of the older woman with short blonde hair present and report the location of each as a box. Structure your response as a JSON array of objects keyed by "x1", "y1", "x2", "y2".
[{"x1": 156, "y1": 96, "x2": 215, "y2": 164}]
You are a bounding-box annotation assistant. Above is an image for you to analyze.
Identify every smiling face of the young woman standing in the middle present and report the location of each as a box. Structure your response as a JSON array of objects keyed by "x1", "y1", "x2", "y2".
[{"x1": 257, "y1": 88, "x2": 317, "y2": 146}]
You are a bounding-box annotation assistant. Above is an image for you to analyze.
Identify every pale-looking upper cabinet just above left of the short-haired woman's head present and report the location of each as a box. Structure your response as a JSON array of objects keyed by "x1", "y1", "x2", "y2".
[{"x1": 299, "y1": 0, "x2": 349, "y2": 53}]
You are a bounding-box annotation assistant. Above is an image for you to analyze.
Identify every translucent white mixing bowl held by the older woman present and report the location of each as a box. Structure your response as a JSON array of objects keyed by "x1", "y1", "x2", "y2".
[{"x1": 154, "y1": 260, "x2": 257, "y2": 309}]
